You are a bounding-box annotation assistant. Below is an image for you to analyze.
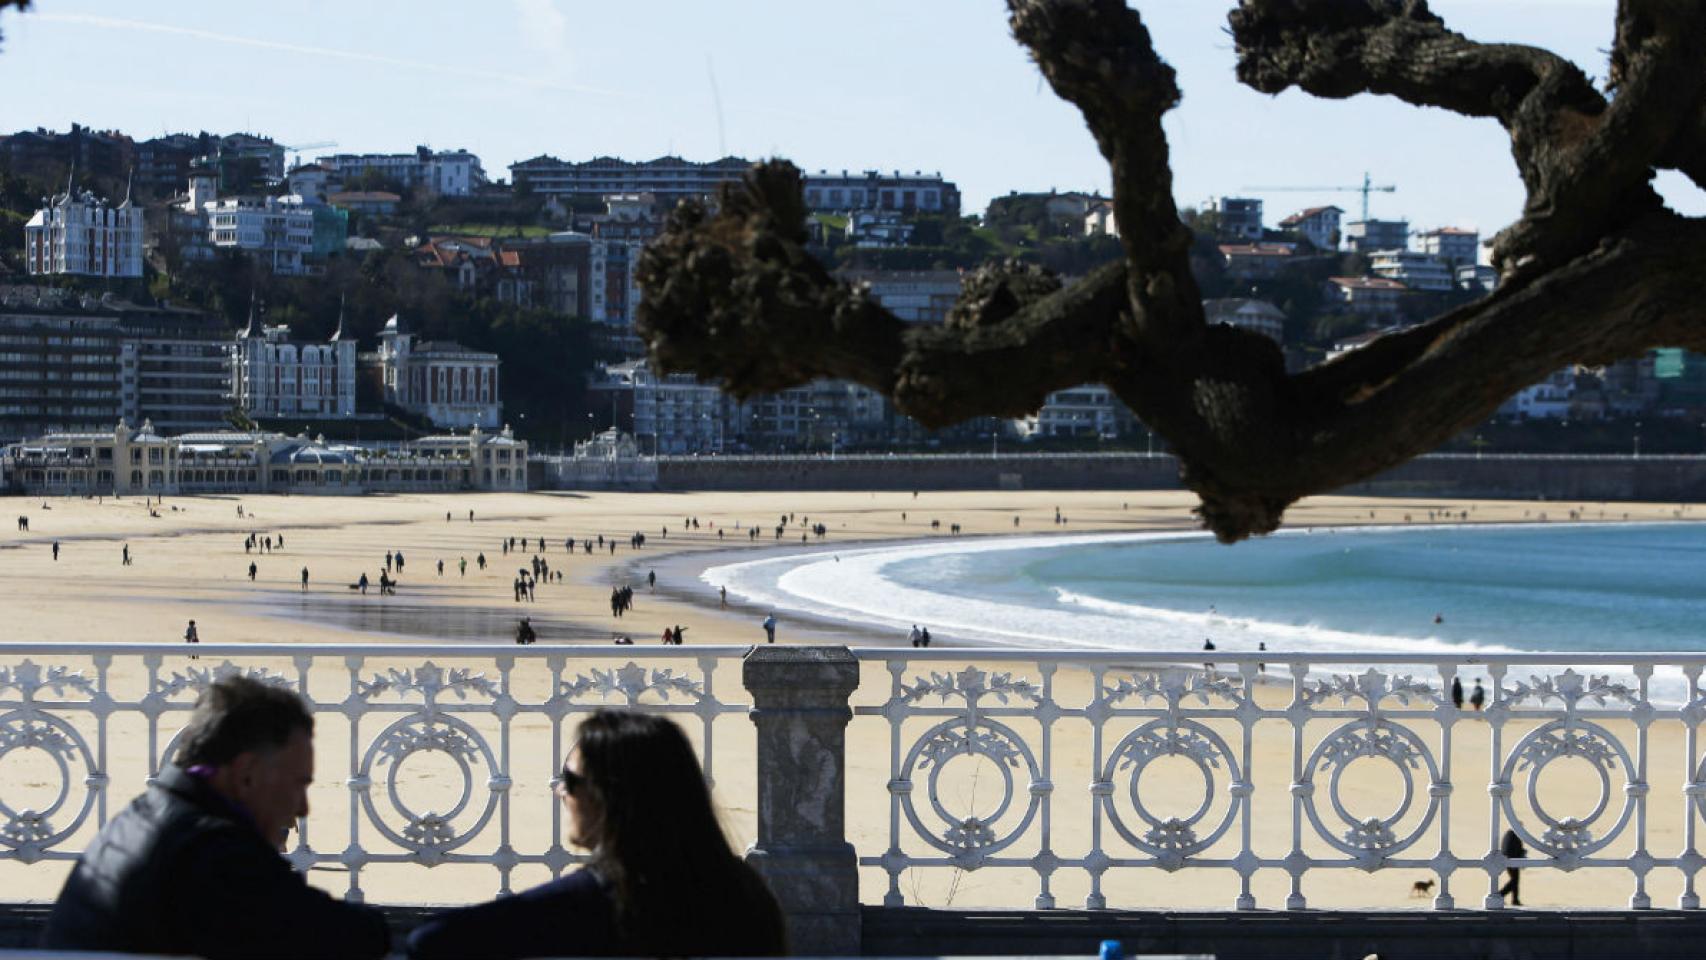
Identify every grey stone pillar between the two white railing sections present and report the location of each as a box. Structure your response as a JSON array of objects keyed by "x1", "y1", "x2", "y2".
[{"x1": 740, "y1": 645, "x2": 860, "y2": 957}]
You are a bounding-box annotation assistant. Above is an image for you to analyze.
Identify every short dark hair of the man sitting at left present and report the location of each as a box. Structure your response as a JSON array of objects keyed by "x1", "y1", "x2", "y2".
[{"x1": 172, "y1": 675, "x2": 314, "y2": 767}]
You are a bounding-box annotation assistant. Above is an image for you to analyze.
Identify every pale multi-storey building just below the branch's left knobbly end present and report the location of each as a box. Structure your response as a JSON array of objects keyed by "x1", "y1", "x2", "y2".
[{"x1": 587, "y1": 360, "x2": 734, "y2": 455}]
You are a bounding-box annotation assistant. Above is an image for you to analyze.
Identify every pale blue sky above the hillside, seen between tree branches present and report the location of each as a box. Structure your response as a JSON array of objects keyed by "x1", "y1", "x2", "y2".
[{"x1": 0, "y1": 0, "x2": 1706, "y2": 237}]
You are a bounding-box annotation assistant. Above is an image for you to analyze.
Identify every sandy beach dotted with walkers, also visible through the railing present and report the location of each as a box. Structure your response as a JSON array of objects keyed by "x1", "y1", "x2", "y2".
[{"x1": 0, "y1": 491, "x2": 1701, "y2": 909}]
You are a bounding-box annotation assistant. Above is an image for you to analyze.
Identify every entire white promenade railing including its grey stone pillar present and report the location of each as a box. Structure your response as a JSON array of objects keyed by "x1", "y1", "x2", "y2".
[{"x1": 0, "y1": 643, "x2": 1706, "y2": 941}]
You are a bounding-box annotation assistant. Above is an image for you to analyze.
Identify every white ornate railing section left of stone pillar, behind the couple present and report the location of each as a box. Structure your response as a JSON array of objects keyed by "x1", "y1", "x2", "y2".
[{"x1": 0, "y1": 643, "x2": 747, "y2": 899}]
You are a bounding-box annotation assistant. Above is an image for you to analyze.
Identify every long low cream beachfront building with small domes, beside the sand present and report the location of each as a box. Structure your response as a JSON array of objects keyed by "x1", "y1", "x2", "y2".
[{"x1": 0, "y1": 421, "x2": 527, "y2": 496}]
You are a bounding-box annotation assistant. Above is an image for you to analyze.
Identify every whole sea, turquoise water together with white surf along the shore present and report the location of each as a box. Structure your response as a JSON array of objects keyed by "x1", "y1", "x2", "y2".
[{"x1": 703, "y1": 522, "x2": 1706, "y2": 655}]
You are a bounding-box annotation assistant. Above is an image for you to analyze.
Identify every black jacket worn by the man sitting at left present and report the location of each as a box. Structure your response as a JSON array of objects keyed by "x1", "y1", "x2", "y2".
[{"x1": 41, "y1": 766, "x2": 391, "y2": 960}]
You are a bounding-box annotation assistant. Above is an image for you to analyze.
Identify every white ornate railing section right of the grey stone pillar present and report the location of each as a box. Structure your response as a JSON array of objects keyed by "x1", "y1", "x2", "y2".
[{"x1": 850, "y1": 648, "x2": 1706, "y2": 909}]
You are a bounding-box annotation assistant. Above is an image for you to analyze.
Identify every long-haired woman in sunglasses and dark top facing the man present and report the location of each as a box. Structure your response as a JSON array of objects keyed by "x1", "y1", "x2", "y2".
[{"x1": 408, "y1": 709, "x2": 786, "y2": 960}]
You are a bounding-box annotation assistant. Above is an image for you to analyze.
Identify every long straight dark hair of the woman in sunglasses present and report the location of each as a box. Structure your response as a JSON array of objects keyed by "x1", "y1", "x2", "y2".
[{"x1": 577, "y1": 709, "x2": 786, "y2": 957}]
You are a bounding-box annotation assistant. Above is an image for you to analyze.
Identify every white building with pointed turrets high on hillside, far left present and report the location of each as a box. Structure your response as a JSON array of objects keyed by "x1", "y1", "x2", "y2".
[{"x1": 24, "y1": 191, "x2": 142, "y2": 276}]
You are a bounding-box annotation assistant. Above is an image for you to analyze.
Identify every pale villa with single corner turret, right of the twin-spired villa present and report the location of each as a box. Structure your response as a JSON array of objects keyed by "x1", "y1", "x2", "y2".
[{"x1": 375, "y1": 315, "x2": 503, "y2": 430}]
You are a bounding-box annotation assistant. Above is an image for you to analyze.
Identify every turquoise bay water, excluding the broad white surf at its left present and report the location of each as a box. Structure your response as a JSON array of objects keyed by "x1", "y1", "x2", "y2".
[{"x1": 880, "y1": 523, "x2": 1706, "y2": 653}]
